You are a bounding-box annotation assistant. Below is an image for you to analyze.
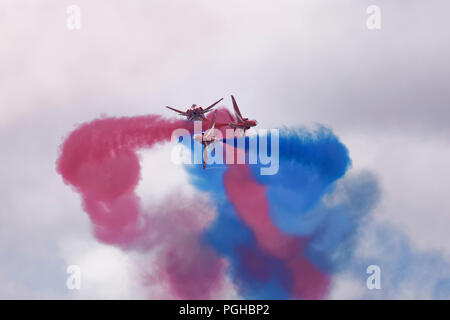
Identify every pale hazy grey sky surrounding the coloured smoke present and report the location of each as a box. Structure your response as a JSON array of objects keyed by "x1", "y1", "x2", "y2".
[{"x1": 0, "y1": 0, "x2": 450, "y2": 298}]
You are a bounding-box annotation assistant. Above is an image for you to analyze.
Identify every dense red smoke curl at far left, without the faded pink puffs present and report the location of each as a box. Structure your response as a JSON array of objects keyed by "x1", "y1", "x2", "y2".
[{"x1": 57, "y1": 116, "x2": 190, "y2": 244}]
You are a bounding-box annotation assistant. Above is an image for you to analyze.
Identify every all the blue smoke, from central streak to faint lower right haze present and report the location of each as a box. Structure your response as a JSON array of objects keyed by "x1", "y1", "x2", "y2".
[{"x1": 181, "y1": 127, "x2": 450, "y2": 299}]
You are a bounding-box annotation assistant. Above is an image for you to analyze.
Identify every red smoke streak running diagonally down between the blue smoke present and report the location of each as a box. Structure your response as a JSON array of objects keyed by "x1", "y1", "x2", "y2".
[{"x1": 224, "y1": 165, "x2": 330, "y2": 299}]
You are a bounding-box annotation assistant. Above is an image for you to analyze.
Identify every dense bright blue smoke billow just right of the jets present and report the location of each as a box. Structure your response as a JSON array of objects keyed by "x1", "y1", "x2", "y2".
[{"x1": 248, "y1": 127, "x2": 351, "y2": 236}]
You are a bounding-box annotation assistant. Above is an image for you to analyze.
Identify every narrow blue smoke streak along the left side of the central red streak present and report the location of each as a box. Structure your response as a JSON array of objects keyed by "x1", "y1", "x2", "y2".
[{"x1": 186, "y1": 165, "x2": 290, "y2": 299}]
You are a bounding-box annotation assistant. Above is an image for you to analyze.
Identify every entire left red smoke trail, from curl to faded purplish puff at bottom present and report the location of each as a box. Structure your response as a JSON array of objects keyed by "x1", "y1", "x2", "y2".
[{"x1": 57, "y1": 115, "x2": 224, "y2": 299}]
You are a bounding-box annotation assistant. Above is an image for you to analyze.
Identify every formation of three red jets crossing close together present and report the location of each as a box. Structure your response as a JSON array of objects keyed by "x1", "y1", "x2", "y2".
[{"x1": 166, "y1": 95, "x2": 258, "y2": 169}]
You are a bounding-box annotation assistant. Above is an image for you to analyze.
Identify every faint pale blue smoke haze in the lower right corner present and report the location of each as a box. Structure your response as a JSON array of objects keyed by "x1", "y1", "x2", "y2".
[{"x1": 344, "y1": 223, "x2": 450, "y2": 299}]
